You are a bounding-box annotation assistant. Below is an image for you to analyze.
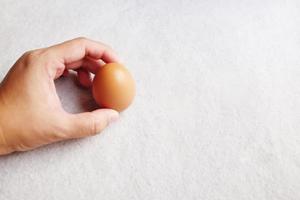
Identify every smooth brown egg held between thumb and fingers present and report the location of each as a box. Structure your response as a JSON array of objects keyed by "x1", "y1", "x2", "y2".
[{"x1": 93, "y1": 63, "x2": 135, "y2": 111}]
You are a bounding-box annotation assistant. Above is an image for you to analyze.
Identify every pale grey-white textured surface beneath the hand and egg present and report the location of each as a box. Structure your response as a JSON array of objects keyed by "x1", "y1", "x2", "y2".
[{"x1": 0, "y1": 0, "x2": 300, "y2": 200}]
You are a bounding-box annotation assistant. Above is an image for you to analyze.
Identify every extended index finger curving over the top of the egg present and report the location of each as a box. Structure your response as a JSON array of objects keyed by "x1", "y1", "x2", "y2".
[{"x1": 48, "y1": 37, "x2": 119, "y2": 65}]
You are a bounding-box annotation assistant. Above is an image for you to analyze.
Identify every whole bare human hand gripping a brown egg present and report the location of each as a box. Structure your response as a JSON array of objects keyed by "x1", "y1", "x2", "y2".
[{"x1": 0, "y1": 38, "x2": 119, "y2": 155}]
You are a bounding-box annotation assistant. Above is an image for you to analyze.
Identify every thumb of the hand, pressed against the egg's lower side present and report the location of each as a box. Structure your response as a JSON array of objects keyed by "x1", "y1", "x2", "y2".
[{"x1": 68, "y1": 109, "x2": 119, "y2": 138}]
